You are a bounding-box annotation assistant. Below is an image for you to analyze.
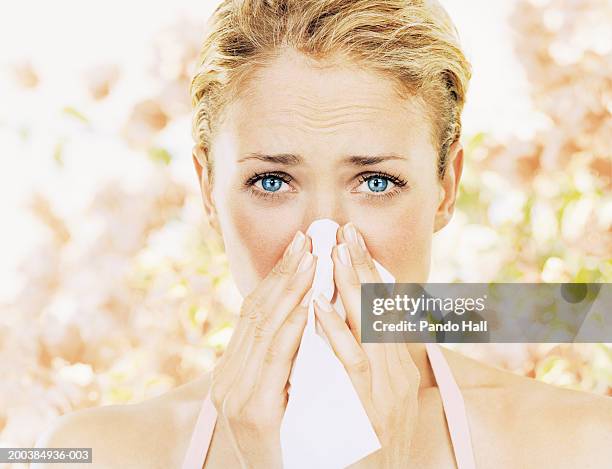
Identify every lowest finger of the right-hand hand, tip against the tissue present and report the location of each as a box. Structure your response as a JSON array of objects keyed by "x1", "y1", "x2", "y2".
[{"x1": 314, "y1": 295, "x2": 372, "y2": 402}]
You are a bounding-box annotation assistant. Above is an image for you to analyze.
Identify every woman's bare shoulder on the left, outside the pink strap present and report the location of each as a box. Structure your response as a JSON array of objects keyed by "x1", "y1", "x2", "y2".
[{"x1": 31, "y1": 374, "x2": 210, "y2": 469}]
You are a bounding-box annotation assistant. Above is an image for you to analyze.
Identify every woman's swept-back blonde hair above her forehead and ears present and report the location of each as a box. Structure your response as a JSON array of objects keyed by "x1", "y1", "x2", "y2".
[{"x1": 190, "y1": 0, "x2": 471, "y2": 183}]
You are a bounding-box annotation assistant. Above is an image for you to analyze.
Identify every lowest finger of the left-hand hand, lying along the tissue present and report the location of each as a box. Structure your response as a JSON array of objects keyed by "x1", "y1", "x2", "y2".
[{"x1": 254, "y1": 294, "x2": 311, "y2": 405}]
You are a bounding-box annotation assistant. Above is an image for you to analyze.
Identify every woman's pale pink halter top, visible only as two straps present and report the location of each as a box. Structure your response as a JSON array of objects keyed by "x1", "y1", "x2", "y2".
[{"x1": 182, "y1": 344, "x2": 476, "y2": 469}]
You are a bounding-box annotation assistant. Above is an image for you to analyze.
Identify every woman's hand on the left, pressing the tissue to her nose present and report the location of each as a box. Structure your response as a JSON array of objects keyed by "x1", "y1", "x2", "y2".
[{"x1": 211, "y1": 231, "x2": 316, "y2": 469}]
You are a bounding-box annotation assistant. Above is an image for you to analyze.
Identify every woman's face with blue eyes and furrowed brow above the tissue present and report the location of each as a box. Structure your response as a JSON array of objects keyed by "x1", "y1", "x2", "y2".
[{"x1": 198, "y1": 48, "x2": 462, "y2": 295}]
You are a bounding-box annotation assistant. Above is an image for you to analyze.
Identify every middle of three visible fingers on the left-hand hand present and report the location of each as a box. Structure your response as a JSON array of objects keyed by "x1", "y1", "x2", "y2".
[{"x1": 231, "y1": 252, "x2": 316, "y2": 400}]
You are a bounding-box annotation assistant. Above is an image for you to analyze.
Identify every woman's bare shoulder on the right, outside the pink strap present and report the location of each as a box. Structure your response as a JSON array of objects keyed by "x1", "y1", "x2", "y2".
[{"x1": 445, "y1": 350, "x2": 612, "y2": 468}]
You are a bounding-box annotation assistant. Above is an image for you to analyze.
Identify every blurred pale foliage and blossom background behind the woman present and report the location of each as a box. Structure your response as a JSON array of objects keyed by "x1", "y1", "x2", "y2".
[{"x1": 0, "y1": 0, "x2": 612, "y2": 458}]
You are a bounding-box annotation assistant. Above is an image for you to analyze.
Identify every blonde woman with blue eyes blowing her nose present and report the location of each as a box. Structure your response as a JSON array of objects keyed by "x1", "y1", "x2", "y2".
[{"x1": 33, "y1": 0, "x2": 612, "y2": 468}]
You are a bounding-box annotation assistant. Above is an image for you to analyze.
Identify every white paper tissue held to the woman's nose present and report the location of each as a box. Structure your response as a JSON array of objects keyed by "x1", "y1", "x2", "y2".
[{"x1": 280, "y1": 218, "x2": 395, "y2": 469}]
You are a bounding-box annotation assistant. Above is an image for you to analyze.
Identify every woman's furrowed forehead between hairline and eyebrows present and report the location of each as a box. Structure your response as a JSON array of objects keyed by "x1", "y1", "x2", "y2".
[{"x1": 215, "y1": 52, "x2": 432, "y2": 159}]
